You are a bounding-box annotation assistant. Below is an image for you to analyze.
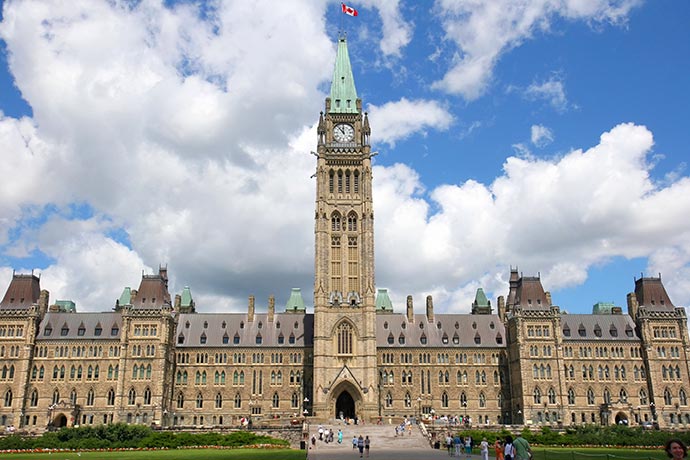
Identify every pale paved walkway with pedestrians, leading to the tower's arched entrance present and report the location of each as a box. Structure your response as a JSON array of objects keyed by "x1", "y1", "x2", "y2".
[{"x1": 307, "y1": 422, "x2": 479, "y2": 460}]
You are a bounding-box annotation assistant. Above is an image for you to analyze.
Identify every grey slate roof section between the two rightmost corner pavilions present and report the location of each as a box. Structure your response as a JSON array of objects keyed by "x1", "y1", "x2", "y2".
[{"x1": 561, "y1": 314, "x2": 640, "y2": 341}]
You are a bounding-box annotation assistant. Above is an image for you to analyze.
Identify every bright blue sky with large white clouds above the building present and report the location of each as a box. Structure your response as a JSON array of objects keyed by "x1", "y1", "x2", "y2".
[{"x1": 0, "y1": 0, "x2": 690, "y2": 312}]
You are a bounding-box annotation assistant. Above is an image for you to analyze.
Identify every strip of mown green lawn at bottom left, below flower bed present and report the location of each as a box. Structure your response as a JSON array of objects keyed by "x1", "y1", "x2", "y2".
[{"x1": 3, "y1": 449, "x2": 306, "y2": 460}]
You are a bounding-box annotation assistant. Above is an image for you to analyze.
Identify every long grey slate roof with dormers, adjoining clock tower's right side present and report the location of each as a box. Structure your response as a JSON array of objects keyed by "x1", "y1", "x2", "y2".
[{"x1": 376, "y1": 313, "x2": 506, "y2": 349}]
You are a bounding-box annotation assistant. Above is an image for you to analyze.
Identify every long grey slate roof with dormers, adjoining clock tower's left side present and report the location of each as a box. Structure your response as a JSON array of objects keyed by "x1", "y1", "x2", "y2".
[{"x1": 175, "y1": 313, "x2": 314, "y2": 348}]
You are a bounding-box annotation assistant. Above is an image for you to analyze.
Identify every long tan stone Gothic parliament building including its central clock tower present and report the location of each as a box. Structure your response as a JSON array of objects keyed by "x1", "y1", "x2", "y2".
[{"x1": 0, "y1": 38, "x2": 690, "y2": 432}]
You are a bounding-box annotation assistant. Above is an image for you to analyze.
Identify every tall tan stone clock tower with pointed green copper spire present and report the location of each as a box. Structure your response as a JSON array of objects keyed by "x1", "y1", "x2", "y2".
[{"x1": 313, "y1": 37, "x2": 378, "y2": 419}]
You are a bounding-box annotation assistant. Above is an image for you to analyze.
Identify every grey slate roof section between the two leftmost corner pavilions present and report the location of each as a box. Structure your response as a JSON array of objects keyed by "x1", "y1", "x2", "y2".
[{"x1": 37, "y1": 312, "x2": 122, "y2": 340}]
